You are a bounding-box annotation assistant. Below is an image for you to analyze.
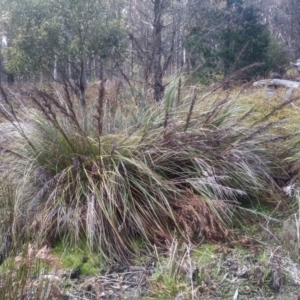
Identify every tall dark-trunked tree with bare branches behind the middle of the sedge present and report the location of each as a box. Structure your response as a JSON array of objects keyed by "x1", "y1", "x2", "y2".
[{"x1": 125, "y1": 0, "x2": 185, "y2": 101}]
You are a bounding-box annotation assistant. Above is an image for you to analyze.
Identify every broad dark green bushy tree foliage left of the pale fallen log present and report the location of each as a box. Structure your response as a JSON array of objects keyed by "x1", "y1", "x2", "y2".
[{"x1": 186, "y1": 0, "x2": 288, "y2": 80}]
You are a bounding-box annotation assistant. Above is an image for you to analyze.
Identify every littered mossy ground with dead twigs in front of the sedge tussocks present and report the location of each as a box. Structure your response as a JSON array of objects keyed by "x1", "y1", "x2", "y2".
[{"x1": 15, "y1": 221, "x2": 300, "y2": 300}]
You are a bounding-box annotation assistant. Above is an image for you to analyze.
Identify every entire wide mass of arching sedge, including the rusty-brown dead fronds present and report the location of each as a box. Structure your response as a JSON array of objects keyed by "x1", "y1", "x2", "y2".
[{"x1": 0, "y1": 84, "x2": 296, "y2": 259}]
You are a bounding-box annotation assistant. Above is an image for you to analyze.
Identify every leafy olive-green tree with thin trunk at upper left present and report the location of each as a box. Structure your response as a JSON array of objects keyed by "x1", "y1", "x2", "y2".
[{"x1": 2, "y1": 0, "x2": 124, "y2": 130}]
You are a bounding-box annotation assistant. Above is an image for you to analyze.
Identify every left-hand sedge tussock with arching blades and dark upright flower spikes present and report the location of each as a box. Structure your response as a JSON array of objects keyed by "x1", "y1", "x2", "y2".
[{"x1": 3, "y1": 83, "x2": 176, "y2": 256}]
